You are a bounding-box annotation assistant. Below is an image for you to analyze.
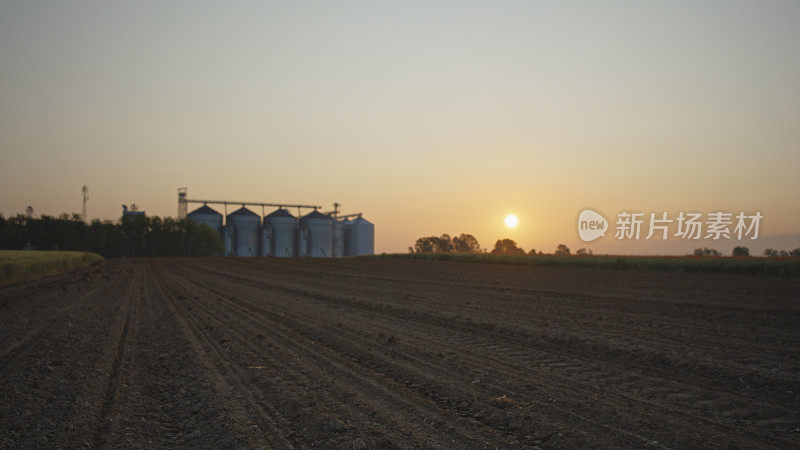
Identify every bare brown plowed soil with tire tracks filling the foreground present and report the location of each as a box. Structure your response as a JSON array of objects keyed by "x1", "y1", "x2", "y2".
[{"x1": 0, "y1": 258, "x2": 800, "y2": 448}]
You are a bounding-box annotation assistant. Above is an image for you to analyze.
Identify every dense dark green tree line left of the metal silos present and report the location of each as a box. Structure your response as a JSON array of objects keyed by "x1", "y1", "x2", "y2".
[{"x1": 0, "y1": 214, "x2": 223, "y2": 258}]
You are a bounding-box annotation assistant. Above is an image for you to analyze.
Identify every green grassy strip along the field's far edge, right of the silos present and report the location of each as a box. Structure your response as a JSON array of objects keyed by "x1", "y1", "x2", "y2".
[{"x1": 367, "y1": 253, "x2": 800, "y2": 276}]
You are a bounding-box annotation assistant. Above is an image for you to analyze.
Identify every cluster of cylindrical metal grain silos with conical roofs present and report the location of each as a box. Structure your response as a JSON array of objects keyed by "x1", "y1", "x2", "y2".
[{"x1": 187, "y1": 205, "x2": 375, "y2": 258}]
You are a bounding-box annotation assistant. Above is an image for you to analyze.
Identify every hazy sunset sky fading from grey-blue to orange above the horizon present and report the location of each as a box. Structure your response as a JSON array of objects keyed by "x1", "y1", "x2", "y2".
[{"x1": 0, "y1": 0, "x2": 800, "y2": 254}]
